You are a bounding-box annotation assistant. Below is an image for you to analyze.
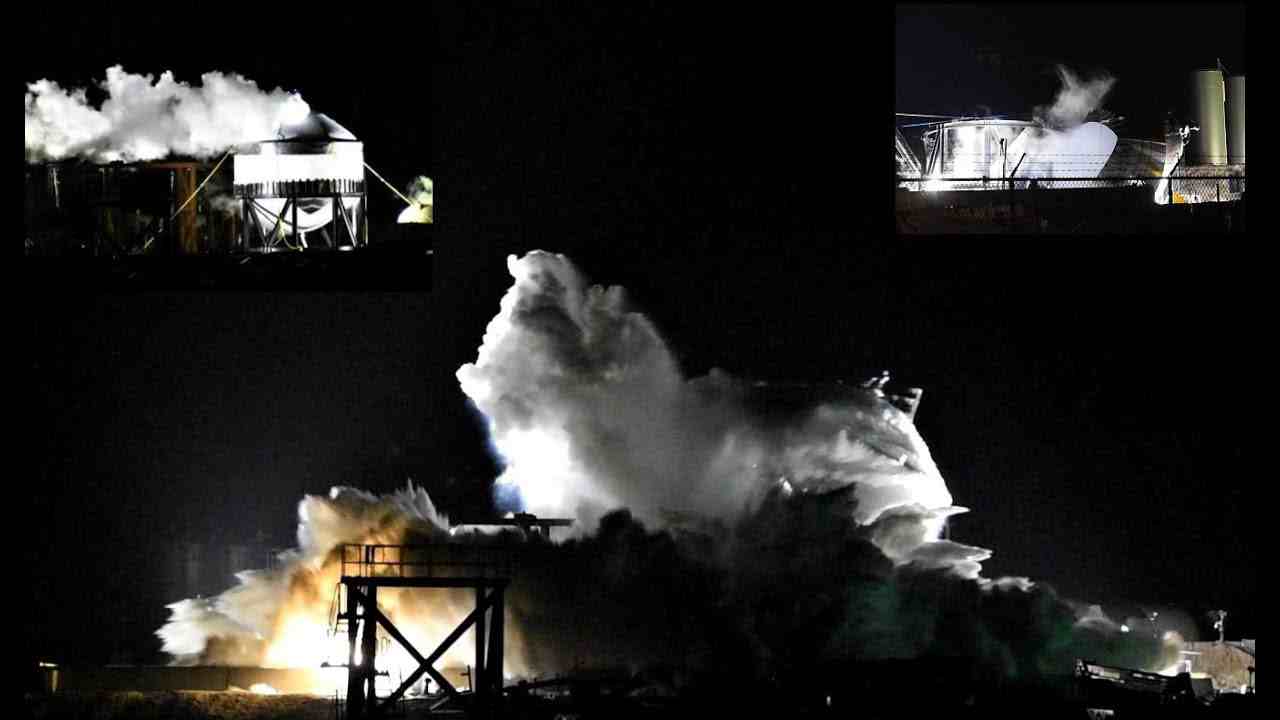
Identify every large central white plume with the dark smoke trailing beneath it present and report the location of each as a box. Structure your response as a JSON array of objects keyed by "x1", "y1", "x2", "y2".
[{"x1": 458, "y1": 252, "x2": 1176, "y2": 676}]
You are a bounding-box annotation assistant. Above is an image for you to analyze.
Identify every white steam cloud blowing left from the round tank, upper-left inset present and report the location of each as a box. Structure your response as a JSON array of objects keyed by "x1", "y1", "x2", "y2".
[{"x1": 26, "y1": 65, "x2": 310, "y2": 163}]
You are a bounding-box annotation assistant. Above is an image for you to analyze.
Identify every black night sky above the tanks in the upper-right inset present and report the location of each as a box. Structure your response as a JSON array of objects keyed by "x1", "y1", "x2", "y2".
[{"x1": 893, "y1": 3, "x2": 1247, "y2": 140}]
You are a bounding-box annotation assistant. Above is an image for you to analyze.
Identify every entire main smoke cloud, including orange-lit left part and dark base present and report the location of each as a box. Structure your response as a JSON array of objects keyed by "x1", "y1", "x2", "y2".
[{"x1": 159, "y1": 252, "x2": 1179, "y2": 687}]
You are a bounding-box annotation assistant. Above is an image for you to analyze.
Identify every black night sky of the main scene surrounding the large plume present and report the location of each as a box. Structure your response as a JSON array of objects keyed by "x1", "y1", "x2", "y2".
[{"x1": 19, "y1": 8, "x2": 1258, "y2": 659}]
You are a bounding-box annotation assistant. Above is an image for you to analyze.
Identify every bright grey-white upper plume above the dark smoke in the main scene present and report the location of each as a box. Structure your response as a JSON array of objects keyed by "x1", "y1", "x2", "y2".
[{"x1": 458, "y1": 252, "x2": 987, "y2": 575}]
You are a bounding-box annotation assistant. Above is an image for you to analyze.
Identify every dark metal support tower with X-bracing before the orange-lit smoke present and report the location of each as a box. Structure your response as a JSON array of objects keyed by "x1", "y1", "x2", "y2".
[{"x1": 338, "y1": 544, "x2": 511, "y2": 720}]
